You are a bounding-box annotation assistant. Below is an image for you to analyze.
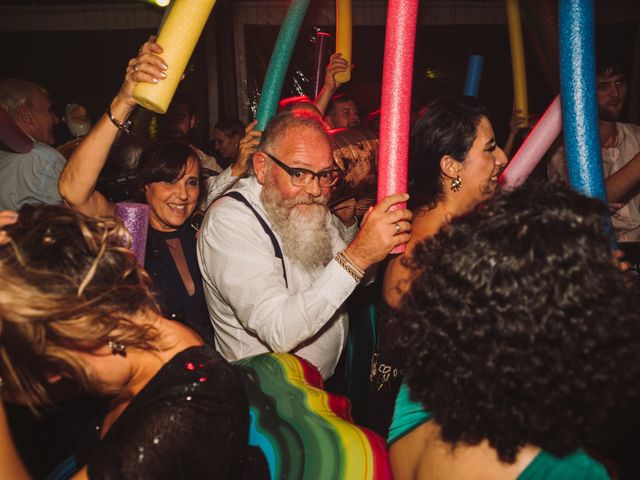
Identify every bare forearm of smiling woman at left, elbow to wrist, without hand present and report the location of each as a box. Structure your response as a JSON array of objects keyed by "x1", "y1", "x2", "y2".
[{"x1": 58, "y1": 97, "x2": 133, "y2": 215}]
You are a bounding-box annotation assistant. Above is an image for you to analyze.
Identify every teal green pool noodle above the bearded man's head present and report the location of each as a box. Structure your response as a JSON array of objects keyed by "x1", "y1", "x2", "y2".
[{"x1": 256, "y1": 0, "x2": 311, "y2": 131}]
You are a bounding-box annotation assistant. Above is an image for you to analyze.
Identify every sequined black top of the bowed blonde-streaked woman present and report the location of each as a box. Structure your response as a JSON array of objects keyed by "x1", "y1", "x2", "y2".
[{"x1": 77, "y1": 346, "x2": 268, "y2": 480}]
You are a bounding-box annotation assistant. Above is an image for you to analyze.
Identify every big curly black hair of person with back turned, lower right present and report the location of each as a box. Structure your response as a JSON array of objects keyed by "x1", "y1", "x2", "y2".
[{"x1": 395, "y1": 182, "x2": 640, "y2": 462}]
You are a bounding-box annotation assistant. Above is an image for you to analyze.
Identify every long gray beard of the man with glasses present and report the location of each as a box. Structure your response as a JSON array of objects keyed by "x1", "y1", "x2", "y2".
[{"x1": 260, "y1": 176, "x2": 333, "y2": 272}]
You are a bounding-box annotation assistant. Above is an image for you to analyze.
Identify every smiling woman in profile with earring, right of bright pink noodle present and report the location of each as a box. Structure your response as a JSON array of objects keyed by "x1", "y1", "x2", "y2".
[{"x1": 347, "y1": 98, "x2": 507, "y2": 435}]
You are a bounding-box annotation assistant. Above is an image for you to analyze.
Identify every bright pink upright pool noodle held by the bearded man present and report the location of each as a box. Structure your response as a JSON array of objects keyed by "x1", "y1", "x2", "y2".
[{"x1": 378, "y1": 0, "x2": 418, "y2": 253}]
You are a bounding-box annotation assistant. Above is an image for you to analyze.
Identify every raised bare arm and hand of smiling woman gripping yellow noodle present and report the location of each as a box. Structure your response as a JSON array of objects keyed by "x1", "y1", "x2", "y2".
[{"x1": 58, "y1": 39, "x2": 167, "y2": 216}]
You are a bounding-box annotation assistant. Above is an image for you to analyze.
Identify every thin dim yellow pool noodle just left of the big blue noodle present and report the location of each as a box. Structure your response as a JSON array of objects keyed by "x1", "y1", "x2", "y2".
[{"x1": 505, "y1": 0, "x2": 529, "y2": 127}]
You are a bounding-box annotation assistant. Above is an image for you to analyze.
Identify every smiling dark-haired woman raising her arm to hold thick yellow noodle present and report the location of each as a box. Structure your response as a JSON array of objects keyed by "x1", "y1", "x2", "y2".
[{"x1": 58, "y1": 41, "x2": 248, "y2": 344}]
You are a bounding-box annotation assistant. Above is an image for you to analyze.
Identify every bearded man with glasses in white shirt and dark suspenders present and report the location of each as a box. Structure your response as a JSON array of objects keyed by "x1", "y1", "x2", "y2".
[{"x1": 198, "y1": 110, "x2": 411, "y2": 379}]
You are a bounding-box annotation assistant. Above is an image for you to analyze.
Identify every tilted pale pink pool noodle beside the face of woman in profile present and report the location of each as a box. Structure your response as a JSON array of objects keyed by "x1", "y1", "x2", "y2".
[{"x1": 500, "y1": 96, "x2": 562, "y2": 190}]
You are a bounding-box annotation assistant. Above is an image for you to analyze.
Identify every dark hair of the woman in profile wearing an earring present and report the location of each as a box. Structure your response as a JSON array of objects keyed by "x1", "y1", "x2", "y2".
[{"x1": 409, "y1": 97, "x2": 486, "y2": 210}]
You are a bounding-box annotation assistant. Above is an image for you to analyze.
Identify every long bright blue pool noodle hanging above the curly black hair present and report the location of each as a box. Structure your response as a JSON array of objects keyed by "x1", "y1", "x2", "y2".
[{"x1": 558, "y1": 0, "x2": 607, "y2": 202}]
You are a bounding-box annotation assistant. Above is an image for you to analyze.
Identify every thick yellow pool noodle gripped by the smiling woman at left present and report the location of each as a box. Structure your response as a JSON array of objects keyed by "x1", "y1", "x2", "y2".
[{"x1": 133, "y1": 0, "x2": 216, "y2": 113}]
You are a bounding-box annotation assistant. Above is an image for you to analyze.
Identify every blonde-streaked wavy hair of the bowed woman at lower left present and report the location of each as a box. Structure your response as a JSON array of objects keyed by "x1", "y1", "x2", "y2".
[{"x1": 0, "y1": 206, "x2": 159, "y2": 407}]
